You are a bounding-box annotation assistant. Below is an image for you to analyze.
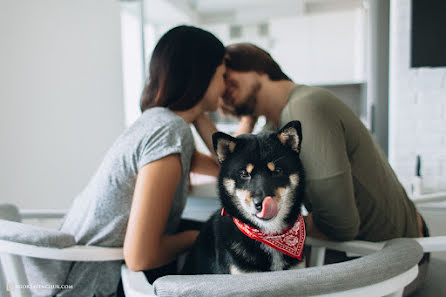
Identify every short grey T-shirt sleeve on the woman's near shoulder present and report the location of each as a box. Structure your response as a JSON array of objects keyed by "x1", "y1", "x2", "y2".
[{"x1": 137, "y1": 122, "x2": 193, "y2": 172}]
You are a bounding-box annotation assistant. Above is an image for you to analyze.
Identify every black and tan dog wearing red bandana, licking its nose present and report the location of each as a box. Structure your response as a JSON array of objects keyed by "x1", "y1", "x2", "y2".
[{"x1": 180, "y1": 121, "x2": 305, "y2": 274}]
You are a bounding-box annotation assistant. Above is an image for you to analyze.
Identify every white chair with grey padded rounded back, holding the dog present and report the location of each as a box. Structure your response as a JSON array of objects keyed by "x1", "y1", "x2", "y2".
[{"x1": 121, "y1": 238, "x2": 423, "y2": 297}]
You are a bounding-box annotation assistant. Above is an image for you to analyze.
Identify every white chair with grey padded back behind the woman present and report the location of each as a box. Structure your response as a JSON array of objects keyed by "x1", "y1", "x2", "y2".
[{"x1": 0, "y1": 204, "x2": 123, "y2": 297}]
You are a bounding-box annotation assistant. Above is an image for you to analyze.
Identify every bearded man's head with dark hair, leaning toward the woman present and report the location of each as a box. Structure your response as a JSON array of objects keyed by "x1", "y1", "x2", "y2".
[{"x1": 223, "y1": 43, "x2": 290, "y2": 115}]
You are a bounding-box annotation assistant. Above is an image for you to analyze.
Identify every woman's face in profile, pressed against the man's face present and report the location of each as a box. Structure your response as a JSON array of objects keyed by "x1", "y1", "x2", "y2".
[{"x1": 203, "y1": 63, "x2": 226, "y2": 111}]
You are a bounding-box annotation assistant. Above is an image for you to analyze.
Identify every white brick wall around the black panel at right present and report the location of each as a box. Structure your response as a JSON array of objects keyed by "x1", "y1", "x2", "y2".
[{"x1": 389, "y1": 0, "x2": 446, "y2": 191}]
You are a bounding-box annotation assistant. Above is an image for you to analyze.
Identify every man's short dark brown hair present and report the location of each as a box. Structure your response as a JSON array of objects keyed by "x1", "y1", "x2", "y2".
[{"x1": 225, "y1": 43, "x2": 290, "y2": 81}]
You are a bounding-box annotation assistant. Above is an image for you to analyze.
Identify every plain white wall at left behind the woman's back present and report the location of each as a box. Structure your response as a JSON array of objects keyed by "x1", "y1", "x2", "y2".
[{"x1": 0, "y1": 0, "x2": 124, "y2": 208}]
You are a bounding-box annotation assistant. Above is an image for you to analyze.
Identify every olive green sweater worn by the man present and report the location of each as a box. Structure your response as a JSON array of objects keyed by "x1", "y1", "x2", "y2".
[{"x1": 270, "y1": 85, "x2": 418, "y2": 241}]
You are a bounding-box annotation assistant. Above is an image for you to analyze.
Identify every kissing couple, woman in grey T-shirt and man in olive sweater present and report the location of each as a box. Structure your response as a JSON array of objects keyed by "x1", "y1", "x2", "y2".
[{"x1": 29, "y1": 26, "x2": 426, "y2": 296}]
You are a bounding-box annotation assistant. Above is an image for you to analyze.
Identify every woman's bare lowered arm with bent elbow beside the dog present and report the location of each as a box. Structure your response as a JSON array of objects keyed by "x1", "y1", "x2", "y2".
[{"x1": 124, "y1": 154, "x2": 198, "y2": 271}]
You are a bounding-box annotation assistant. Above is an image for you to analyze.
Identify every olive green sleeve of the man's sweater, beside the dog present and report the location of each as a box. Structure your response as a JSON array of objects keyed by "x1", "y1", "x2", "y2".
[{"x1": 285, "y1": 98, "x2": 360, "y2": 240}]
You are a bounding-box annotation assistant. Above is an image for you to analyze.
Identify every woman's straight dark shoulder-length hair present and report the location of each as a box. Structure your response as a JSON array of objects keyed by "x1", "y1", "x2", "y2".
[{"x1": 140, "y1": 26, "x2": 225, "y2": 111}]
